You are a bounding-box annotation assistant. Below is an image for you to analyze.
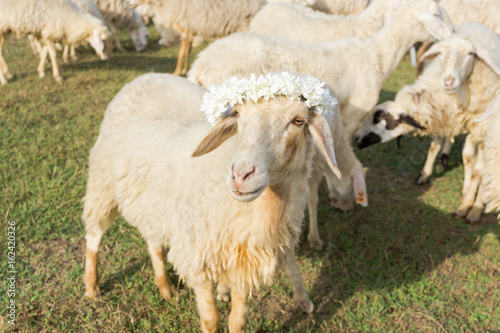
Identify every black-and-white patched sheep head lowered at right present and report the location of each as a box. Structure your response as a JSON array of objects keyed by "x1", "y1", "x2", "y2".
[{"x1": 354, "y1": 101, "x2": 425, "y2": 148}]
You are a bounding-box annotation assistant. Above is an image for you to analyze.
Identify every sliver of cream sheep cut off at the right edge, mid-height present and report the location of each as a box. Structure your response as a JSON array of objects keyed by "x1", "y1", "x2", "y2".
[{"x1": 481, "y1": 96, "x2": 500, "y2": 219}]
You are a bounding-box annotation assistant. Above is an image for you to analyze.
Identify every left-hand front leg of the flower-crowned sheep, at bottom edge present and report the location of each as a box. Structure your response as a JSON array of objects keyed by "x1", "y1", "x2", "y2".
[{"x1": 193, "y1": 281, "x2": 219, "y2": 333}]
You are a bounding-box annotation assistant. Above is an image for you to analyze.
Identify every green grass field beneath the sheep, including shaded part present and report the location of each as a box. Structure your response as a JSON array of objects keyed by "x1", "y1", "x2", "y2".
[{"x1": 0, "y1": 29, "x2": 500, "y2": 332}]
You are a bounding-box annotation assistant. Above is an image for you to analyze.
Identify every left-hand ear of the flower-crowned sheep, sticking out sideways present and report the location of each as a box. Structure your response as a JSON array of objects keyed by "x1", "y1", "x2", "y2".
[{"x1": 191, "y1": 117, "x2": 238, "y2": 157}]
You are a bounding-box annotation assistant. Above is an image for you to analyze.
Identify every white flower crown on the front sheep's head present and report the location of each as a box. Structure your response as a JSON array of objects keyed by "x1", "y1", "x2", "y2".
[{"x1": 200, "y1": 72, "x2": 337, "y2": 125}]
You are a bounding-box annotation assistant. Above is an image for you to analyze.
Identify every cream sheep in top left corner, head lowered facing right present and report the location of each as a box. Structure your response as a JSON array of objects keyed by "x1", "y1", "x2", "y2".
[{"x1": 0, "y1": 0, "x2": 109, "y2": 84}]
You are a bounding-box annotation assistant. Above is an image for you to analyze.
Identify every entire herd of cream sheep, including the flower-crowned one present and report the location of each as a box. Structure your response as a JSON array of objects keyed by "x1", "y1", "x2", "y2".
[{"x1": 0, "y1": 0, "x2": 500, "y2": 332}]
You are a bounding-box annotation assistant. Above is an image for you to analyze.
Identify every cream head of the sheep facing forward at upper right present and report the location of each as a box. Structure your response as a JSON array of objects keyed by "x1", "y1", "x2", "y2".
[{"x1": 421, "y1": 33, "x2": 500, "y2": 94}]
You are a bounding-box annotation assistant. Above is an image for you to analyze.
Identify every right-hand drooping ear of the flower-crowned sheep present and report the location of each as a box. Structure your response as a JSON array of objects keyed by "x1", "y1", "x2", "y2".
[{"x1": 309, "y1": 113, "x2": 342, "y2": 179}]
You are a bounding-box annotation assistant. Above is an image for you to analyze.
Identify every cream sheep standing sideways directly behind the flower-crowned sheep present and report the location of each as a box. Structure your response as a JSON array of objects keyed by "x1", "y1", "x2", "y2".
[{"x1": 188, "y1": 0, "x2": 453, "y2": 138}]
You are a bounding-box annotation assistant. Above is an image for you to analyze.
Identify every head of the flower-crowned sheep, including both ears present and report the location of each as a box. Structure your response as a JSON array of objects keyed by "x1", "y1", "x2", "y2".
[{"x1": 193, "y1": 96, "x2": 340, "y2": 202}]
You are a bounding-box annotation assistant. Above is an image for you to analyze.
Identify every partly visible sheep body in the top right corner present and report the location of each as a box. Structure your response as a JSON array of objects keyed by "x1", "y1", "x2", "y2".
[{"x1": 439, "y1": 0, "x2": 500, "y2": 35}]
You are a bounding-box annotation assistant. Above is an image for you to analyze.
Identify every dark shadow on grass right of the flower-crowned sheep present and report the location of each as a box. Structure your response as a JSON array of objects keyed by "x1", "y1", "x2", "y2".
[{"x1": 282, "y1": 134, "x2": 500, "y2": 332}]
